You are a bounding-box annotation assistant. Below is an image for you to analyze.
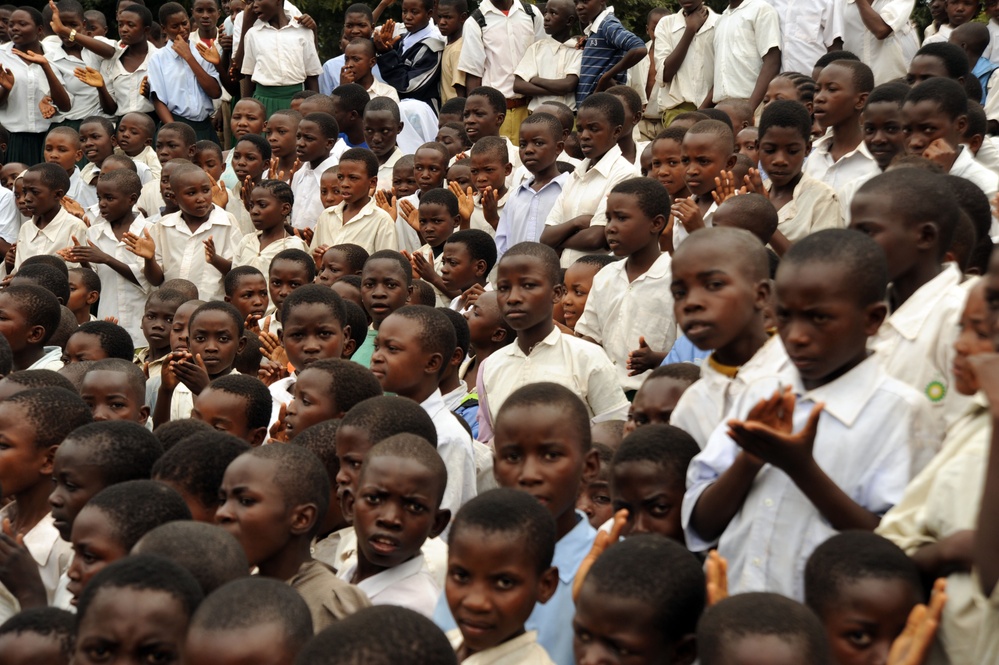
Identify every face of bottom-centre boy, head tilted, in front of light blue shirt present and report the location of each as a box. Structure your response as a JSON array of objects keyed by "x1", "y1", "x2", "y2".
[{"x1": 444, "y1": 526, "x2": 558, "y2": 653}]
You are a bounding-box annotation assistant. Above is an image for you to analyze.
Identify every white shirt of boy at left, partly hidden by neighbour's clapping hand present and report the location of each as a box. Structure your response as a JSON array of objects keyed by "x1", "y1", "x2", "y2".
[{"x1": 88, "y1": 215, "x2": 152, "y2": 348}]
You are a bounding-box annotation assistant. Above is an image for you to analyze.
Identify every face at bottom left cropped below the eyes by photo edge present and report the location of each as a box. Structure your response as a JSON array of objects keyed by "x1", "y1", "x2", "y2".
[{"x1": 73, "y1": 587, "x2": 190, "y2": 665}]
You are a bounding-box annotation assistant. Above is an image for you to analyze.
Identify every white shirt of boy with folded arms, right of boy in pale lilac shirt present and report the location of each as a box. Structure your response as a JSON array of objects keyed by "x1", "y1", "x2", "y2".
[{"x1": 545, "y1": 144, "x2": 640, "y2": 268}]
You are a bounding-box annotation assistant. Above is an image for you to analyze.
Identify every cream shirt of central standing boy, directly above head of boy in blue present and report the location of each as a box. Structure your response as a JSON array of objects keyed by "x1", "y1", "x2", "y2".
[{"x1": 478, "y1": 328, "x2": 628, "y2": 423}]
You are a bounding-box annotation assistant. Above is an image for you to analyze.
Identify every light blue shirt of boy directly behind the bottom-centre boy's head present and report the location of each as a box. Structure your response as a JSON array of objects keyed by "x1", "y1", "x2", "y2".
[{"x1": 434, "y1": 510, "x2": 597, "y2": 665}]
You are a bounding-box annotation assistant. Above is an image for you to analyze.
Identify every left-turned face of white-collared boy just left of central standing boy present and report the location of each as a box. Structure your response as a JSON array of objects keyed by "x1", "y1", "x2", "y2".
[{"x1": 371, "y1": 316, "x2": 445, "y2": 397}]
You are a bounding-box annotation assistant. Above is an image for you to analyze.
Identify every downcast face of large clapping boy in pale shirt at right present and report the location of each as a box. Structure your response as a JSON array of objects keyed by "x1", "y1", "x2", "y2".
[{"x1": 776, "y1": 260, "x2": 885, "y2": 390}]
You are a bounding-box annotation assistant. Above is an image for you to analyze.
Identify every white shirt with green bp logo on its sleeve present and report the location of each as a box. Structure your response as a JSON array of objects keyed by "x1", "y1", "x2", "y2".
[{"x1": 867, "y1": 263, "x2": 968, "y2": 444}]
